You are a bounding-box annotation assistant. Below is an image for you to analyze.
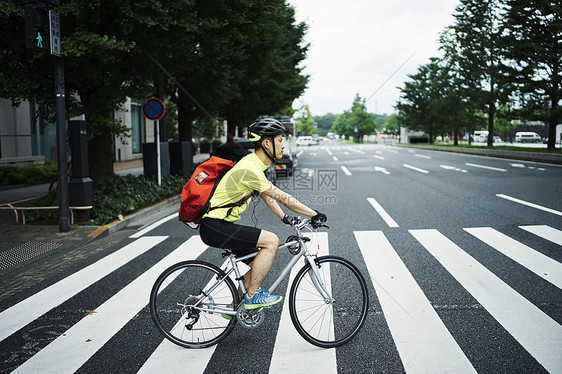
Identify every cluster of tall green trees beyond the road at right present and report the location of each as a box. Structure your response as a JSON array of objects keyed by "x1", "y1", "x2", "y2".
[{"x1": 396, "y1": 0, "x2": 562, "y2": 149}]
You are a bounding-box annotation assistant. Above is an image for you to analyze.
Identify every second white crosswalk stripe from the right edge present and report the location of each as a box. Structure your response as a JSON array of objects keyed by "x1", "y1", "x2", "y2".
[{"x1": 464, "y1": 227, "x2": 562, "y2": 289}]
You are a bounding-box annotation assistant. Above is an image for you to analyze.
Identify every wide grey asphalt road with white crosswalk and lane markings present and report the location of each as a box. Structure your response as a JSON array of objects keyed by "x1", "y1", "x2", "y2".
[{"x1": 0, "y1": 142, "x2": 562, "y2": 373}]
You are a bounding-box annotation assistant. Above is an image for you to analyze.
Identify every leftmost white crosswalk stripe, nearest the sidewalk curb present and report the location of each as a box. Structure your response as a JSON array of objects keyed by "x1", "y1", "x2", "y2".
[{"x1": 0, "y1": 236, "x2": 168, "y2": 341}]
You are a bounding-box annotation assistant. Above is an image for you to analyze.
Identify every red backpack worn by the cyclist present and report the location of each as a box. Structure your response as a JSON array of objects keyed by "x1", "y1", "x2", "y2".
[{"x1": 179, "y1": 156, "x2": 251, "y2": 229}]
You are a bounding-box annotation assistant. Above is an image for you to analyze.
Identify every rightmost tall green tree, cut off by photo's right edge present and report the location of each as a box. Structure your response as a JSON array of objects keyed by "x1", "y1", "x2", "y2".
[{"x1": 503, "y1": 0, "x2": 562, "y2": 149}]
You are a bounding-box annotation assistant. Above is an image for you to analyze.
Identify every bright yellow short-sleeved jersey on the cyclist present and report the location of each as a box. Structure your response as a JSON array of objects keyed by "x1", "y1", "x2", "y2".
[{"x1": 203, "y1": 153, "x2": 271, "y2": 222}]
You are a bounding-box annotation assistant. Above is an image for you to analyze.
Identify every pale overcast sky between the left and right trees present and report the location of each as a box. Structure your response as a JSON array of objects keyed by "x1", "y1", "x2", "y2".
[{"x1": 289, "y1": 0, "x2": 459, "y2": 115}]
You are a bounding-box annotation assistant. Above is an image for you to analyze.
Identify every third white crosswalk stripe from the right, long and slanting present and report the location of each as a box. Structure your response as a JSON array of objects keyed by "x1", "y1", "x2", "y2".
[{"x1": 410, "y1": 230, "x2": 562, "y2": 373}]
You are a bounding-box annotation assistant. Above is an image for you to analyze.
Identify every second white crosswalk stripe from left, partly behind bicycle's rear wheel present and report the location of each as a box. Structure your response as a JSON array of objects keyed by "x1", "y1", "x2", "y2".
[{"x1": 14, "y1": 236, "x2": 208, "y2": 374}]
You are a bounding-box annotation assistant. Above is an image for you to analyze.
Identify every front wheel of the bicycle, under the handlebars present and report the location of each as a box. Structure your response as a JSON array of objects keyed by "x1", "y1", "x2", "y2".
[{"x1": 289, "y1": 256, "x2": 369, "y2": 348}]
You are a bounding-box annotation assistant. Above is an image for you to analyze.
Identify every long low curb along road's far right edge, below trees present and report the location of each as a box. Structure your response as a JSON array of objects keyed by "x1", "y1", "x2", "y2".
[{"x1": 396, "y1": 144, "x2": 562, "y2": 165}]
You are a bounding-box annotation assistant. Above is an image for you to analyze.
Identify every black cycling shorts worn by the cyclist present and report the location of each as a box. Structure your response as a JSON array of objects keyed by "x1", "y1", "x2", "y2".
[{"x1": 199, "y1": 218, "x2": 261, "y2": 264}]
